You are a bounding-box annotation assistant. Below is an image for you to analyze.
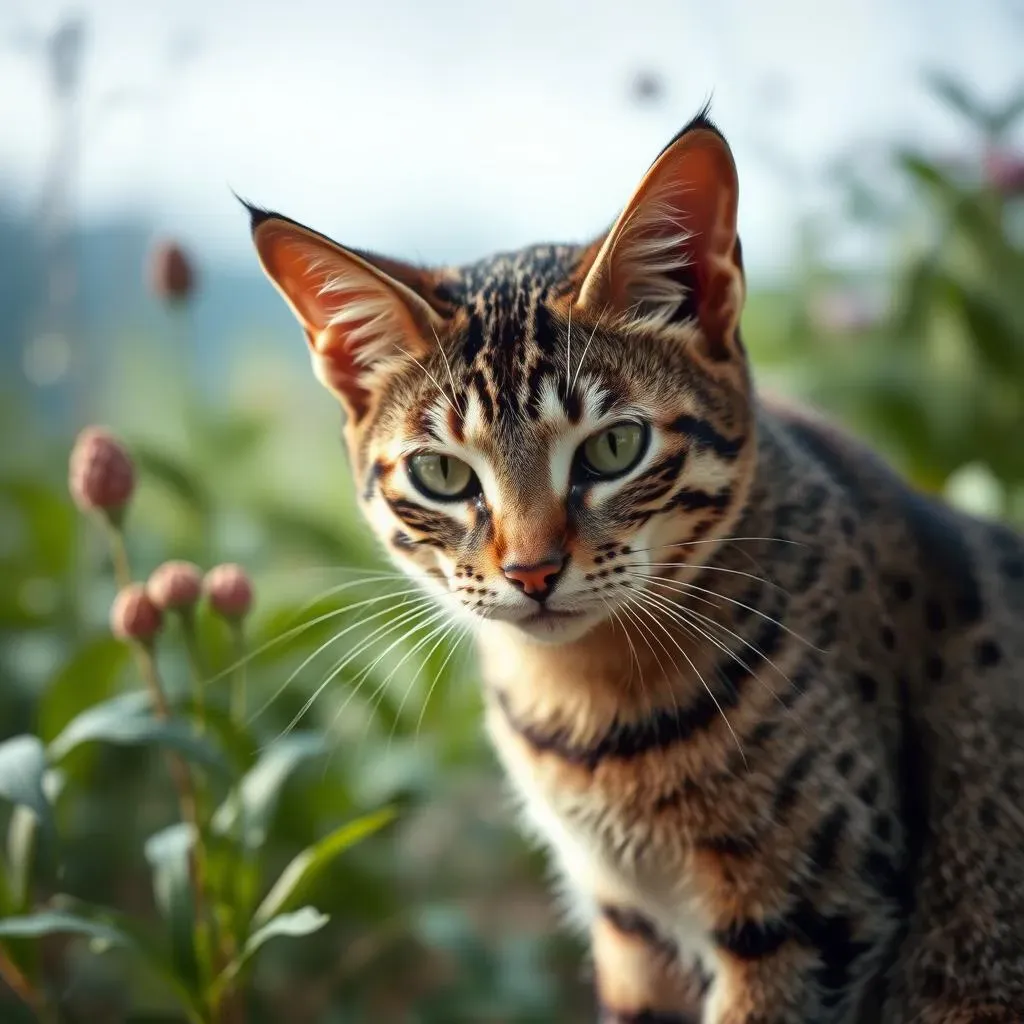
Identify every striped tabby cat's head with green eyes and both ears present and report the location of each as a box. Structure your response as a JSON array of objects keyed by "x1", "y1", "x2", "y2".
[{"x1": 251, "y1": 114, "x2": 754, "y2": 642}]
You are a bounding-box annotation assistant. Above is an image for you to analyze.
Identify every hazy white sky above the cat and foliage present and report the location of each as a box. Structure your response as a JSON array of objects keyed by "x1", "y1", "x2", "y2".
[{"x1": 0, "y1": 0, "x2": 1024, "y2": 273}]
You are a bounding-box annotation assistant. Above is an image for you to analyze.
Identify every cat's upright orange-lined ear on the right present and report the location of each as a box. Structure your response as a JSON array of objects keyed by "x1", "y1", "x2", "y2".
[{"x1": 577, "y1": 113, "x2": 744, "y2": 359}]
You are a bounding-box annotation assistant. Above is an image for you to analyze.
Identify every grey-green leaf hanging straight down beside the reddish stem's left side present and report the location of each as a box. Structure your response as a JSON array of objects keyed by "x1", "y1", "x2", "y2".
[{"x1": 145, "y1": 822, "x2": 200, "y2": 987}]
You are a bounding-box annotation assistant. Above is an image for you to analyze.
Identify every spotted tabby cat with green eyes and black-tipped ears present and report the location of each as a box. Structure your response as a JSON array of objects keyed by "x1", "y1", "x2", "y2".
[{"x1": 251, "y1": 113, "x2": 1024, "y2": 1024}]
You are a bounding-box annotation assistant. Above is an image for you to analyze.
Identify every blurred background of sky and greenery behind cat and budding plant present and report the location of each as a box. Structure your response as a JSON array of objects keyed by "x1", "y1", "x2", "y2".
[{"x1": 0, "y1": 0, "x2": 1024, "y2": 1024}]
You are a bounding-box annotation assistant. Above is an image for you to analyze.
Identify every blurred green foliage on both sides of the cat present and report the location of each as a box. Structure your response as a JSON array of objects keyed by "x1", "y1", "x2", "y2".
[{"x1": 0, "y1": 70, "x2": 1024, "y2": 1024}]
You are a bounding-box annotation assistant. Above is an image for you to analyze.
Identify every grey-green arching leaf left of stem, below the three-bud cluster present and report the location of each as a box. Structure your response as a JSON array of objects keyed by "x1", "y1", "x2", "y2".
[{"x1": 49, "y1": 692, "x2": 225, "y2": 771}]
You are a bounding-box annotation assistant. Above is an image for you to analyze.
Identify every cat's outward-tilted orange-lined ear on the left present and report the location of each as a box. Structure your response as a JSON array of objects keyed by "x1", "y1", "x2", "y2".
[{"x1": 249, "y1": 207, "x2": 443, "y2": 421}]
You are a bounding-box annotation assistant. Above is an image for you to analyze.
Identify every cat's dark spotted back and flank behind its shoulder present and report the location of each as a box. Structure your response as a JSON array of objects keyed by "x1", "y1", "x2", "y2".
[{"x1": 765, "y1": 391, "x2": 1024, "y2": 1022}]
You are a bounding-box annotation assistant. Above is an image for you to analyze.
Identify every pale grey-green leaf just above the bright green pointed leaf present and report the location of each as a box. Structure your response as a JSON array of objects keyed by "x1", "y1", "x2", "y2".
[{"x1": 213, "y1": 732, "x2": 327, "y2": 850}]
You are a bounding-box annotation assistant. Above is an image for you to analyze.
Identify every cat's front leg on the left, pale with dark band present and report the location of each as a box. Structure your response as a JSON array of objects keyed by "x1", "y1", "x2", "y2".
[{"x1": 591, "y1": 905, "x2": 707, "y2": 1024}]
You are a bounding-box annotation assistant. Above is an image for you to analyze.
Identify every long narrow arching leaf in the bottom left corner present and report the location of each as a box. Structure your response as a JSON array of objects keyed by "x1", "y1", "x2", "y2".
[{"x1": 0, "y1": 898, "x2": 205, "y2": 1024}]
